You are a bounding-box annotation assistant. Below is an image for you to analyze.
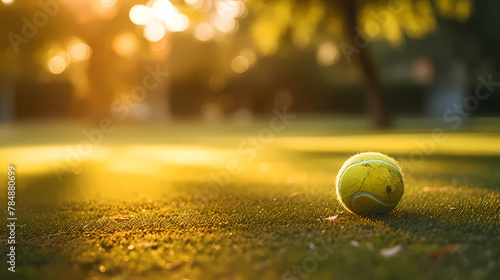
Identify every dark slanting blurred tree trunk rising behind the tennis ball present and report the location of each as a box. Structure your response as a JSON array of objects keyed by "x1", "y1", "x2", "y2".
[{"x1": 344, "y1": 0, "x2": 391, "y2": 127}]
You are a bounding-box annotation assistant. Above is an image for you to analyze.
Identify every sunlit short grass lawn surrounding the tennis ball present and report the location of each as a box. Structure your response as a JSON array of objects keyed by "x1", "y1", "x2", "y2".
[{"x1": 0, "y1": 119, "x2": 500, "y2": 280}]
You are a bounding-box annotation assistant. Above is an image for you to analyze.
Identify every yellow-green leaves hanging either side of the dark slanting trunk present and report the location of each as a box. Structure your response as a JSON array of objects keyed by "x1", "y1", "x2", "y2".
[{"x1": 247, "y1": 0, "x2": 472, "y2": 54}]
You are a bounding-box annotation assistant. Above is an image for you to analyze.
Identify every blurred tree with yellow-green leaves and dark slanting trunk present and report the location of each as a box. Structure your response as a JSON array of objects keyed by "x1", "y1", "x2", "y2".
[{"x1": 247, "y1": 0, "x2": 472, "y2": 127}]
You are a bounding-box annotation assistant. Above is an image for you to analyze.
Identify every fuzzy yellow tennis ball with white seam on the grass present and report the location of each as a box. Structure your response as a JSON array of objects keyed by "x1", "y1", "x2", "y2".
[{"x1": 335, "y1": 152, "x2": 404, "y2": 216}]
